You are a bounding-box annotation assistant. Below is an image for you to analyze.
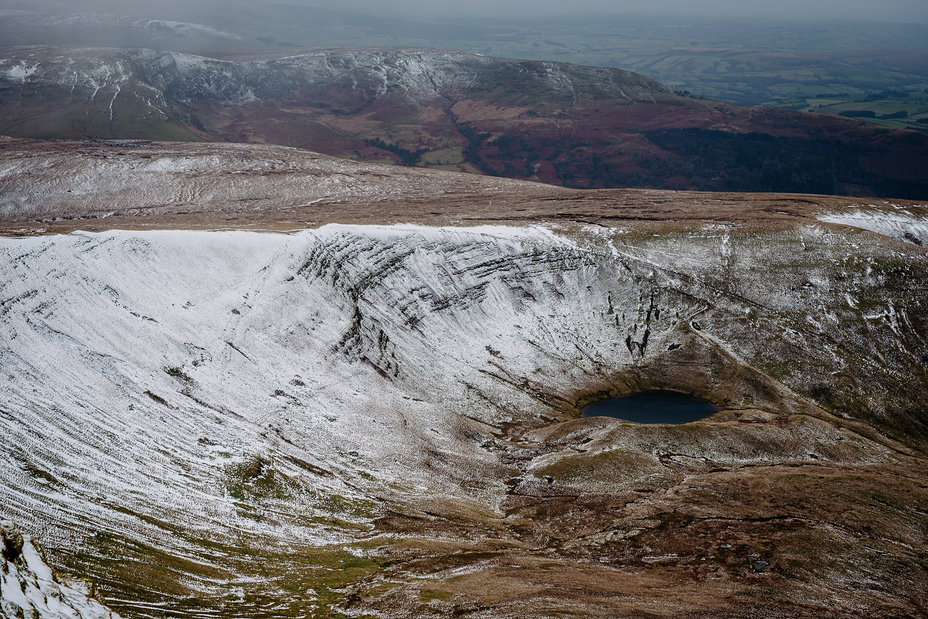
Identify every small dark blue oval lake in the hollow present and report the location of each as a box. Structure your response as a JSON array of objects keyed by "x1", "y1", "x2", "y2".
[{"x1": 580, "y1": 391, "x2": 721, "y2": 423}]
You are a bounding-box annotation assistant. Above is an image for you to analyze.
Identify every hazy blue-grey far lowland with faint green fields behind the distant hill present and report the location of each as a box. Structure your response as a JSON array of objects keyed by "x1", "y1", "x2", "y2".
[{"x1": 0, "y1": 0, "x2": 928, "y2": 120}]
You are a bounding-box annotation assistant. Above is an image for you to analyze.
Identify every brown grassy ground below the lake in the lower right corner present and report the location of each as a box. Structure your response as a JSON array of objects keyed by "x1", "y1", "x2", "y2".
[{"x1": 354, "y1": 428, "x2": 928, "y2": 617}]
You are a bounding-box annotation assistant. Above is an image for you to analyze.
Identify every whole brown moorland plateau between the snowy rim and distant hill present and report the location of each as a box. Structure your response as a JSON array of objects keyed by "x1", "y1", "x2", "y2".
[{"x1": 0, "y1": 138, "x2": 928, "y2": 237}]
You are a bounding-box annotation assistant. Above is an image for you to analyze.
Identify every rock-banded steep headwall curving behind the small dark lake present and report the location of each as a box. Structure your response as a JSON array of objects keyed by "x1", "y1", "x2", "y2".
[{"x1": 288, "y1": 226, "x2": 926, "y2": 436}]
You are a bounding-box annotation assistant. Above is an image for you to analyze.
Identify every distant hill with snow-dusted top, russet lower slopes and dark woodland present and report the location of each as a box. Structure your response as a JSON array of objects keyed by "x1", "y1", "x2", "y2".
[{"x1": 0, "y1": 45, "x2": 928, "y2": 199}]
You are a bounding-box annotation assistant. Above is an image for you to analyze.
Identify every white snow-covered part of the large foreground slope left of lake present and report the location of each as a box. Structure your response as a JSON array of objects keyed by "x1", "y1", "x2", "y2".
[{"x1": 0, "y1": 226, "x2": 918, "y2": 537}]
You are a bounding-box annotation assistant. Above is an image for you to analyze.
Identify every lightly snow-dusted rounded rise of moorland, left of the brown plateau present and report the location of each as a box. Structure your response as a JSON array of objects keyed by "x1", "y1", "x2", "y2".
[{"x1": 0, "y1": 140, "x2": 544, "y2": 221}]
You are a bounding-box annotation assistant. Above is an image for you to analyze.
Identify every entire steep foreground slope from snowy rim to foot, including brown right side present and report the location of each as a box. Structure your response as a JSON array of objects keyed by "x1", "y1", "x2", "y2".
[{"x1": 0, "y1": 225, "x2": 928, "y2": 613}]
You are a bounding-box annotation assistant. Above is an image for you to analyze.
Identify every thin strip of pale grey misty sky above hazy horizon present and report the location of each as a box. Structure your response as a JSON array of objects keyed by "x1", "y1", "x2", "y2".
[{"x1": 316, "y1": 0, "x2": 928, "y2": 23}]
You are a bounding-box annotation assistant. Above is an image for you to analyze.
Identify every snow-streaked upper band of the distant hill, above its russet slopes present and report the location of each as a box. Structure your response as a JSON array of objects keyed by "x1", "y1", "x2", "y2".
[{"x1": 0, "y1": 46, "x2": 672, "y2": 114}]
